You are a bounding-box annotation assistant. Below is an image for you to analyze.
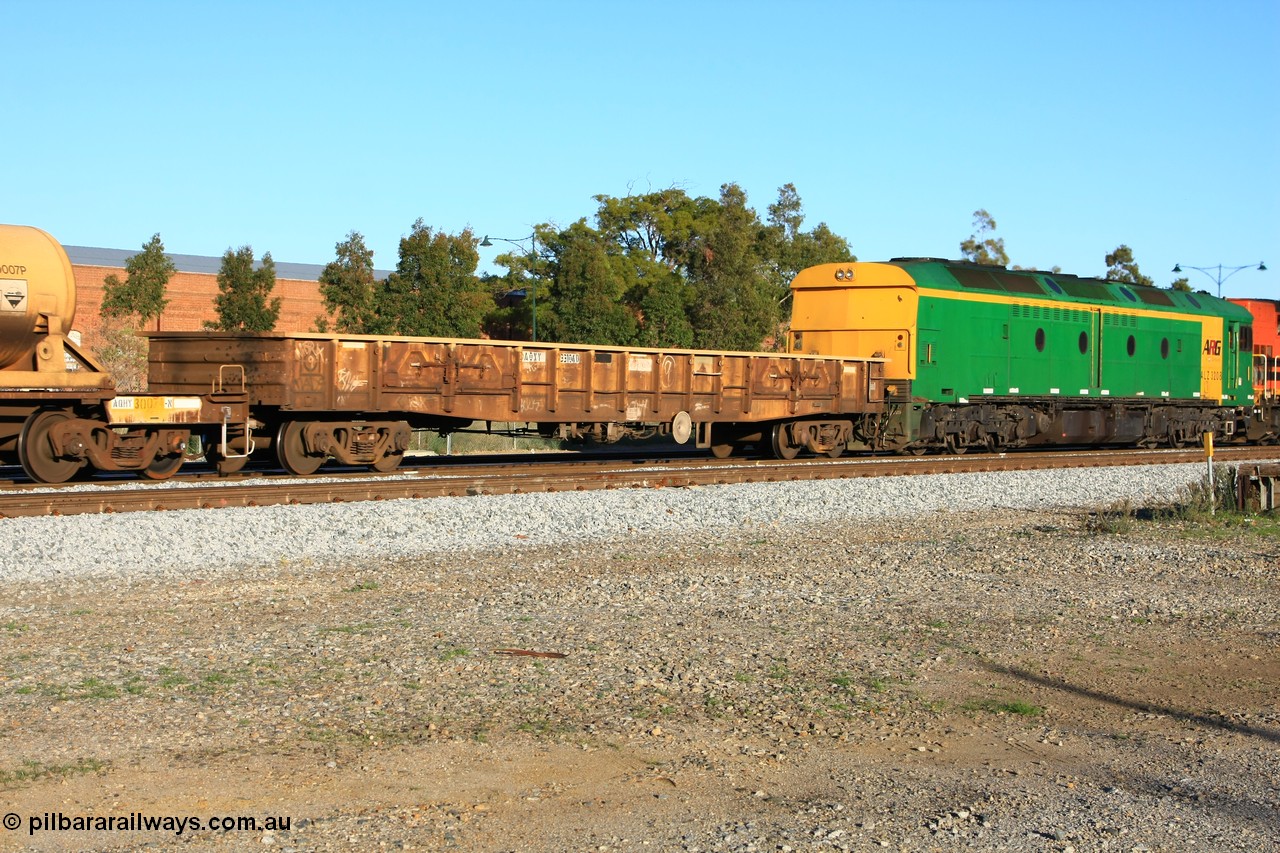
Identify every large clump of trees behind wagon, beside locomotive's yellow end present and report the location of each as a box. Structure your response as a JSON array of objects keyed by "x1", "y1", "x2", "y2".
[{"x1": 486, "y1": 183, "x2": 852, "y2": 350}]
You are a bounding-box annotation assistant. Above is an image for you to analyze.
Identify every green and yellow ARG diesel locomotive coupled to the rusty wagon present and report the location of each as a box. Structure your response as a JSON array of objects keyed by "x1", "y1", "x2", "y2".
[{"x1": 788, "y1": 259, "x2": 1277, "y2": 453}]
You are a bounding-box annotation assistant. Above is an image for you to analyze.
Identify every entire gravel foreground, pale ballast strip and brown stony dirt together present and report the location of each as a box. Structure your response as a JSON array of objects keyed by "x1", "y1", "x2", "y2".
[{"x1": 0, "y1": 466, "x2": 1280, "y2": 850}]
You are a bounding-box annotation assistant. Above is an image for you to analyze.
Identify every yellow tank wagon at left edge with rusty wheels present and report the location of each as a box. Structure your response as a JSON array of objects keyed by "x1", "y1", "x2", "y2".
[{"x1": 0, "y1": 225, "x2": 247, "y2": 483}]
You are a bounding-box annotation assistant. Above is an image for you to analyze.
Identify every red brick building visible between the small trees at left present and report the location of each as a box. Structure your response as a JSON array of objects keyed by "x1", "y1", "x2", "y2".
[{"x1": 63, "y1": 246, "x2": 345, "y2": 351}]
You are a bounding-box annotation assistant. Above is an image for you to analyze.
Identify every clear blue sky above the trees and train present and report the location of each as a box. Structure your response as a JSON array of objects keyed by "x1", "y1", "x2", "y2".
[{"x1": 0, "y1": 0, "x2": 1280, "y2": 298}]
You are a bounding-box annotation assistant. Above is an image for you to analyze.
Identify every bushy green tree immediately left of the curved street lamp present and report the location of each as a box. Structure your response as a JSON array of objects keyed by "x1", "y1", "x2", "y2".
[{"x1": 374, "y1": 219, "x2": 493, "y2": 338}]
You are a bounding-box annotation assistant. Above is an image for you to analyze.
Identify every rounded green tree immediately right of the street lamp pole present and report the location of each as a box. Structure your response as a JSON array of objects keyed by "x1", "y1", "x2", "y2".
[{"x1": 539, "y1": 220, "x2": 637, "y2": 346}]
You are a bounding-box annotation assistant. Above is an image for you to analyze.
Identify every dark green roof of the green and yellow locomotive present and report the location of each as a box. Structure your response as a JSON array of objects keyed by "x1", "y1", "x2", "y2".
[{"x1": 890, "y1": 257, "x2": 1252, "y2": 323}]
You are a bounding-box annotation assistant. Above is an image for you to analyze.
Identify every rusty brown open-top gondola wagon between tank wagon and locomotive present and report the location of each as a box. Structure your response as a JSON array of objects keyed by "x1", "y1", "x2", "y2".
[{"x1": 148, "y1": 332, "x2": 884, "y2": 474}]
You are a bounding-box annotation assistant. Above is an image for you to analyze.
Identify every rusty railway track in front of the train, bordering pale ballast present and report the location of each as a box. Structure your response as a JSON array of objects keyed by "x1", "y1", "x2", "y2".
[{"x1": 0, "y1": 447, "x2": 1280, "y2": 517}]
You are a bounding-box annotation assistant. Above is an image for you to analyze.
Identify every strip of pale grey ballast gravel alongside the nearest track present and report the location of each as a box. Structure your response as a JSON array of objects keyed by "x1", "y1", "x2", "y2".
[{"x1": 0, "y1": 465, "x2": 1249, "y2": 580}]
